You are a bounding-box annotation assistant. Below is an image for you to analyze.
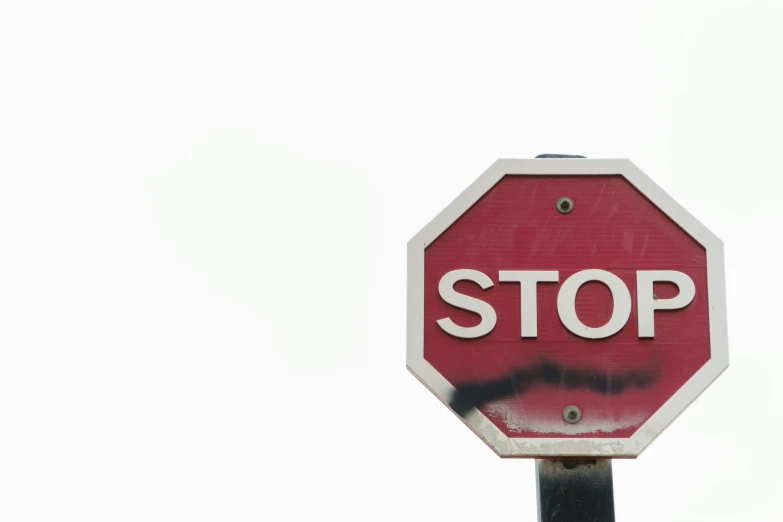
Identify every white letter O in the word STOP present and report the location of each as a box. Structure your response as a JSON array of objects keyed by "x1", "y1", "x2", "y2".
[{"x1": 557, "y1": 269, "x2": 631, "y2": 339}]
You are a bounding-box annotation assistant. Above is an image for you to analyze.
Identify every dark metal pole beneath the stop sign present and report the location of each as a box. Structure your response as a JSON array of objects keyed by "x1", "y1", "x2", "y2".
[{"x1": 536, "y1": 459, "x2": 614, "y2": 522}]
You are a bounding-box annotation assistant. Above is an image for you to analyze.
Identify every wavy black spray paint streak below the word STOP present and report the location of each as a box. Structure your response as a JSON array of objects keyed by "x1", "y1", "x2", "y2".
[{"x1": 449, "y1": 361, "x2": 658, "y2": 416}]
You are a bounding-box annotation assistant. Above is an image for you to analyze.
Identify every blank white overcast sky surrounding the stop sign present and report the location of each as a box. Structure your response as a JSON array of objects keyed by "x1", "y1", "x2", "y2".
[{"x1": 0, "y1": 0, "x2": 783, "y2": 522}]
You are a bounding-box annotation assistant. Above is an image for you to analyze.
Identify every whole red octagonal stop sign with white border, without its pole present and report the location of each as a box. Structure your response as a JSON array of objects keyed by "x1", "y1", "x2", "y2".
[{"x1": 407, "y1": 159, "x2": 728, "y2": 457}]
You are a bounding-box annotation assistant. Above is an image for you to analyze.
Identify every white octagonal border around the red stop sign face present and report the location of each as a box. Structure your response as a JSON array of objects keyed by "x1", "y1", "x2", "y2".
[{"x1": 407, "y1": 158, "x2": 729, "y2": 458}]
